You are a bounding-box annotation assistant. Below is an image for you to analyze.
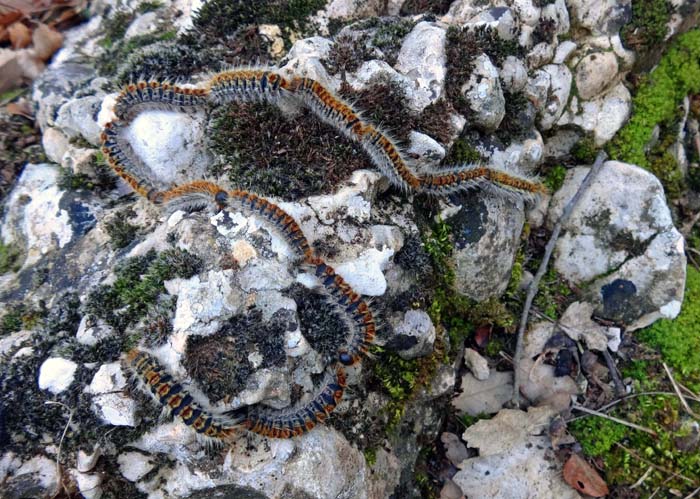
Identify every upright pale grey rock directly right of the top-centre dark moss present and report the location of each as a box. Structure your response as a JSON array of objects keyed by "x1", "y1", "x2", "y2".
[{"x1": 461, "y1": 54, "x2": 506, "y2": 131}]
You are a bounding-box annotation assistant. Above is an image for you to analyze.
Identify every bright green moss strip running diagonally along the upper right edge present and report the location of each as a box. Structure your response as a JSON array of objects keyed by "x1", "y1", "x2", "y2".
[{"x1": 608, "y1": 29, "x2": 700, "y2": 168}]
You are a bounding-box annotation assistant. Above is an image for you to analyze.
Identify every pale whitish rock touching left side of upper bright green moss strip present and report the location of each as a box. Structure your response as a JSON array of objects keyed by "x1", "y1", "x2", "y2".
[{"x1": 557, "y1": 83, "x2": 632, "y2": 146}]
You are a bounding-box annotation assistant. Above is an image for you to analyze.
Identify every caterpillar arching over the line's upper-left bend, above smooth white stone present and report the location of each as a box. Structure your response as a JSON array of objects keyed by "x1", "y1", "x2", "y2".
[{"x1": 114, "y1": 80, "x2": 209, "y2": 121}]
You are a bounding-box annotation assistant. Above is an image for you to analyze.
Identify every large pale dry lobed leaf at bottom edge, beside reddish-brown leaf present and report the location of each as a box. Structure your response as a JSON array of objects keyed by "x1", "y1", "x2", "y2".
[{"x1": 452, "y1": 408, "x2": 580, "y2": 499}]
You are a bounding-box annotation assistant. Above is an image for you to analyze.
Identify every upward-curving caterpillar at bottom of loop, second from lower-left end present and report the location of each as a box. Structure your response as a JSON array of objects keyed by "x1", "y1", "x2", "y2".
[{"x1": 234, "y1": 365, "x2": 347, "y2": 438}]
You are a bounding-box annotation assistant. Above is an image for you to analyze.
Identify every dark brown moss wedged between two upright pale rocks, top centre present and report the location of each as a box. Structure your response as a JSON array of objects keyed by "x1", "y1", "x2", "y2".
[{"x1": 445, "y1": 26, "x2": 521, "y2": 116}]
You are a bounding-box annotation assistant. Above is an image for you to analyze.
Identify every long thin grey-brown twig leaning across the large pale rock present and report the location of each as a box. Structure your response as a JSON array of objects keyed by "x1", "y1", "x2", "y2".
[{"x1": 511, "y1": 151, "x2": 607, "y2": 407}]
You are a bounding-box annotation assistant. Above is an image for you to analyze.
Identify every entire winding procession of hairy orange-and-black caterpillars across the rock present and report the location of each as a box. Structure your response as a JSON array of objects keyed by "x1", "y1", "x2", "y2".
[{"x1": 101, "y1": 69, "x2": 545, "y2": 440}]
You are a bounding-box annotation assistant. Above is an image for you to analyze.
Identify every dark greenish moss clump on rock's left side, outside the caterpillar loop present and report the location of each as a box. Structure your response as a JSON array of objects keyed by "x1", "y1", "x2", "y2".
[{"x1": 85, "y1": 249, "x2": 202, "y2": 332}]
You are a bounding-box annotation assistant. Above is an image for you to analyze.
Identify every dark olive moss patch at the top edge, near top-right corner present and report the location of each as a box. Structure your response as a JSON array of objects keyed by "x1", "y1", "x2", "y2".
[{"x1": 620, "y1": 0, "x2": 673, "y2": 50}]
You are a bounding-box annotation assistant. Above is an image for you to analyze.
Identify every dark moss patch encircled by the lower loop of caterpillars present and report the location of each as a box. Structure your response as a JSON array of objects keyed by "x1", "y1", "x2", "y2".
[{"x1": 184, "y1": 309, "x2": 288, "y2": 403}]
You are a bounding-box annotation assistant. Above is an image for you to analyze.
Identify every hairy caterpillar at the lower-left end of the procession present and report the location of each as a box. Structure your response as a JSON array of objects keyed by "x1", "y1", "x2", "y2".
[{"x1": 125, "y1": 349, "x2": 241, "y2": 441}]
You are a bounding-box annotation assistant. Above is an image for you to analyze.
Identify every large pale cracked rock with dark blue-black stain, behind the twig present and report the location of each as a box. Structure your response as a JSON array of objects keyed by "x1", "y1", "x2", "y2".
[{"x1": 549, "y1": 161, "x2": 685, "y2": 330}]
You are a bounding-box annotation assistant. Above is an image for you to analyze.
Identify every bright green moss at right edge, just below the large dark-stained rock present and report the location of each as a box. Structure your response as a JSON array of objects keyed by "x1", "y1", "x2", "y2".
[{"x1": 638, "y1": 266, "x2": 700, "y2": 392}]
